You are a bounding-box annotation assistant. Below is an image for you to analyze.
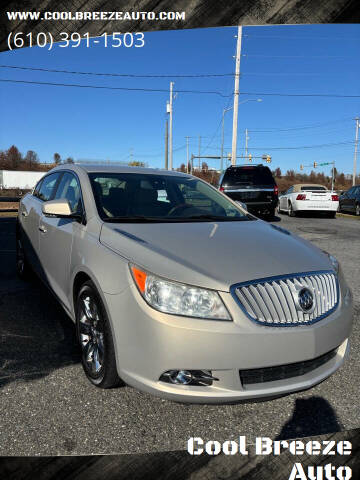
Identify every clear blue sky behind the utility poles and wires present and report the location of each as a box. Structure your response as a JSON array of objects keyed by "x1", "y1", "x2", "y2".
[{"x1": 0, "y1": 25, "x2": 360, "y2": 174}]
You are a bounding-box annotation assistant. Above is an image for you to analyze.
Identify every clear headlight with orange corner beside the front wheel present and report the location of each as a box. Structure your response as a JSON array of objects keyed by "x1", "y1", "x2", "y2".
[{"x1": 130, "y1": 265, "x2": 231, "y2": 320}]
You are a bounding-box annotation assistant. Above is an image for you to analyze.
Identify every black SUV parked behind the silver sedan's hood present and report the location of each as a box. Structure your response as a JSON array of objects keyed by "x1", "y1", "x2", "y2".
[{"x1": 219, "y1": 165, "x2": 278, "y2": 218}]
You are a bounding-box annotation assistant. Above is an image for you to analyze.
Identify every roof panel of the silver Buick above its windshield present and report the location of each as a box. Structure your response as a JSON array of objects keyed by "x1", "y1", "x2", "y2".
[{"x1": 45, "y1": 163, "x2": 192, "y2": 177}]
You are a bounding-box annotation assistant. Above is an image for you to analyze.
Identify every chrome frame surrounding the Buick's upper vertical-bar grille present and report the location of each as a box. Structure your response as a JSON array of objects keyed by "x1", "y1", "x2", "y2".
[{"x1": 230, "y1": 269, "x2": 340, "y2": 328}]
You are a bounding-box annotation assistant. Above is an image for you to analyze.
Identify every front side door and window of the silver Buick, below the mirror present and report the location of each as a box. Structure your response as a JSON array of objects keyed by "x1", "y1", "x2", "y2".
[{"x1": 39, "y1": 171, "x2": 85, "y2": 309}]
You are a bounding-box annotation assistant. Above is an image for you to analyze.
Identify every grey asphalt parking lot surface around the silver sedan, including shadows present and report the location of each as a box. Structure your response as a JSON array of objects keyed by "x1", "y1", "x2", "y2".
[{"x1": 0, "y1": 215, "x2": 360, "y2": 455}]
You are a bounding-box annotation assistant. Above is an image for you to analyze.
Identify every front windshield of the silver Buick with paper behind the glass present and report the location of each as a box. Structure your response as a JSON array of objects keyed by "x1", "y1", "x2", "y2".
[{"x1": 89, "y1": 172, "x2": 255, "y2": 223}]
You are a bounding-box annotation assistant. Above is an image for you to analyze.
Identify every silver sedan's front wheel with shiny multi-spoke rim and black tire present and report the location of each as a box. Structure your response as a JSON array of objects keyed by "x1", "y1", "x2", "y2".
[{"x1": 76, "y1": 281, "x2": 122, "y2": 388}]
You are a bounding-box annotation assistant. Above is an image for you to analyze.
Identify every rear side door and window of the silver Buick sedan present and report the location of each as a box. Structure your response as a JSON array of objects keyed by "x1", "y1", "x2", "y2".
[{"x1": 19, "y1": 172, "x2": 60, "y2": 276}]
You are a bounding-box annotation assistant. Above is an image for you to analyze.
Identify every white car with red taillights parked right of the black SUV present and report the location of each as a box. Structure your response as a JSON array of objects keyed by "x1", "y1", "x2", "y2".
[{"x1": 278, "y1": 183, "x2": 339, "y2": 218}]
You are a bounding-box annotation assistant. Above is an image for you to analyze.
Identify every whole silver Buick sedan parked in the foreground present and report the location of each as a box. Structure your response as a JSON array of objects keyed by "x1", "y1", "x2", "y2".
[{"x1": 16, "y1": 165, "x2": 352, "y2": 403}]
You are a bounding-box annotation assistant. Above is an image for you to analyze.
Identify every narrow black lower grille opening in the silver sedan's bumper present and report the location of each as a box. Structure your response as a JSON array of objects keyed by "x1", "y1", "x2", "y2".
[{"x1": 240, "y1": 348, "x2": 337, "y2": 387}]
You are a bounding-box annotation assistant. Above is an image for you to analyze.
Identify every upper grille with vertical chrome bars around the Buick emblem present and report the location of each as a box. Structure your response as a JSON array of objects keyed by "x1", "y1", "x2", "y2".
[{"x1": 232, "y1": 271, "x2": 339, "y2": 326}]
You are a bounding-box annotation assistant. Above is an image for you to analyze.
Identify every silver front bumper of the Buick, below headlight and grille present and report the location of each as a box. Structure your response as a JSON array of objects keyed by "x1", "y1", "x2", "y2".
[{"x1": 105, "y1": 276, "x2": 353, "y2": 403}]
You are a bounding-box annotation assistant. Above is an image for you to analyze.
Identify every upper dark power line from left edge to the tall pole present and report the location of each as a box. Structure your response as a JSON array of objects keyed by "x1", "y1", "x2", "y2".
[{"x1": 0, "y1": 65, "x2": 234, "y2": 78}]
